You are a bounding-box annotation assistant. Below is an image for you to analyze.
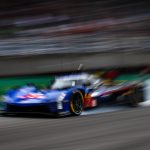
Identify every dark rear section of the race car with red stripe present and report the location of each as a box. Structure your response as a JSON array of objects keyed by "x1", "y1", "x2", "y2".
[{"x1": 90, "y1": 82, "x2": 144, "y2": 106}]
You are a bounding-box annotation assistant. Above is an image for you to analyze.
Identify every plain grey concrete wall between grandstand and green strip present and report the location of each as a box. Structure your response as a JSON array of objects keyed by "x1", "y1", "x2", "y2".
[{"x1": 0, "y1": 51, "x2": 150, "y2": 76}]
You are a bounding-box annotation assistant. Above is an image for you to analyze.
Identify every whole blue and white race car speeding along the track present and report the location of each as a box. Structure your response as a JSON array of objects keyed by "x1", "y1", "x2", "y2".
[{"x1": 3, "y1": 73, "x2": 144, "y2": 116}]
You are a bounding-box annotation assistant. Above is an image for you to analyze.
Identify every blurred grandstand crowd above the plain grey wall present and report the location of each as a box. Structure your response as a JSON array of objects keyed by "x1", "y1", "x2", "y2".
[{"x1": 0, "y1": 0, "x2": 150, "y2": 55}]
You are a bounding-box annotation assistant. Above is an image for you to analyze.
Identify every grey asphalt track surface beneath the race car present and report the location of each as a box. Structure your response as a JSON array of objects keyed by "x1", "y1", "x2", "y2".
[{"x1": 0, "y1": 107, "x2": 150, "y2": 150}]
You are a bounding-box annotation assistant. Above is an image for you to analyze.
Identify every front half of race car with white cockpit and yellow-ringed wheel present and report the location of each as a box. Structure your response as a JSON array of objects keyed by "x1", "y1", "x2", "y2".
[{"x1": 1, "y1": 73, "x2": 97, "y2": 116}]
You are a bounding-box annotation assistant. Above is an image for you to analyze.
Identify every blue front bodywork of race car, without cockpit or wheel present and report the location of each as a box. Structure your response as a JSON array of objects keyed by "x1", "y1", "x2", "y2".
[{"x1": 4, "y1": 74, "x2": 87, "y2": 114}]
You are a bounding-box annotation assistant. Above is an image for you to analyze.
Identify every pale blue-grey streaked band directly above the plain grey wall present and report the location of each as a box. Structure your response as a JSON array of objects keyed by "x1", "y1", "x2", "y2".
[{"x1": 0, "y1": 33, "x2": 150, "y2": 56}]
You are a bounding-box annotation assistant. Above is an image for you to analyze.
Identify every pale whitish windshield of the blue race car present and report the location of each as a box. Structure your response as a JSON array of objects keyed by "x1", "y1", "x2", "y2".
[{"x1": 51, "y1": 79, "x2": 76, "y2": 89}]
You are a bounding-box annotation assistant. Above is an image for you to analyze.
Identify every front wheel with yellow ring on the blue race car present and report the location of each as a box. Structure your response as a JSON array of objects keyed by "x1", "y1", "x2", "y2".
[{"x1": 70, "y1": 91, "x2": 84, "y2": 116}]
